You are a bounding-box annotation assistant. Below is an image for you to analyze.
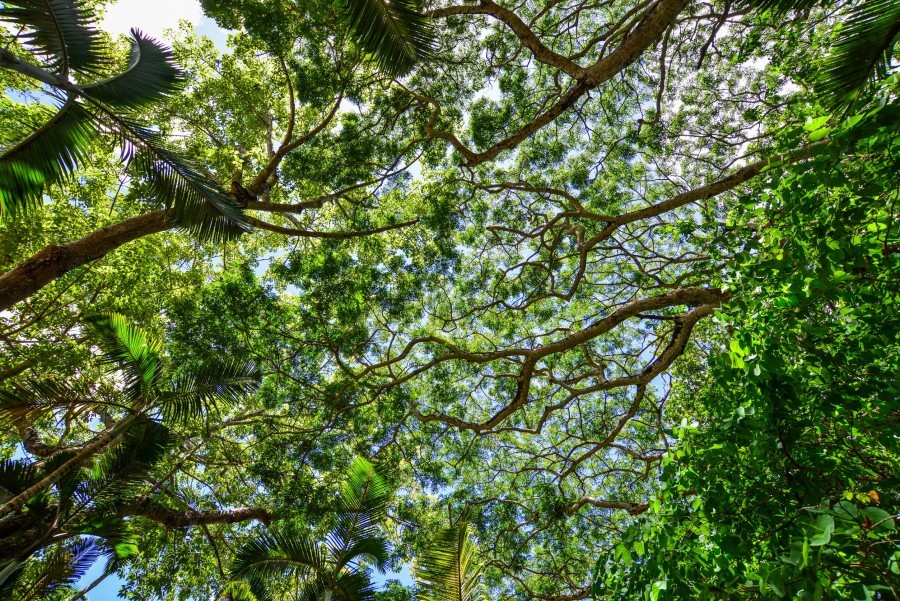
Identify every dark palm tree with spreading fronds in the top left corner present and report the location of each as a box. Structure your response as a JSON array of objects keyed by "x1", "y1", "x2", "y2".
[{"x1": 0, "y1": 0, "x2": 248, "y2": 239}]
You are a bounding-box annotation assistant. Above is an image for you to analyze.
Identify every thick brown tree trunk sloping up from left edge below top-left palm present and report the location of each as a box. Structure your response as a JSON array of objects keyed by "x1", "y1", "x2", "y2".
[{"x1": 0, "y1": 211, "x2": 175, "y2": 311}]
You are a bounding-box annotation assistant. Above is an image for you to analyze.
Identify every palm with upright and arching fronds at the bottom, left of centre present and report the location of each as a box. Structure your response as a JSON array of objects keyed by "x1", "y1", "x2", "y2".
[{"x1": 229, "y1": 458, "x2": 390, "y2": 601}]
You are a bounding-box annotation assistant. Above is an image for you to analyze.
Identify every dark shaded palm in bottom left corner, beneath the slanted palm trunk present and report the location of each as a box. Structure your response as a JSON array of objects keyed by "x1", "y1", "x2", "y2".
[{"x1": 0, "y1": 419, "x2": 165, "y2": 601}]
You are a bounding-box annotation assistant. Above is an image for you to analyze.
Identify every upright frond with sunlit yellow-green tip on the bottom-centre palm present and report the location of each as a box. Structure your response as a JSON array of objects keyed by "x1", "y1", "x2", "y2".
[{"x1": 333, "y1": 457, "x2": 391, "y2": 549}]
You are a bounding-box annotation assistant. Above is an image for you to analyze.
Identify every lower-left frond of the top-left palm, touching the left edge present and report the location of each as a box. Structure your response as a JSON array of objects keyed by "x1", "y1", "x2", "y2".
[{"x1": 0, "y1": 96, "x2": 99, "y2": 219}]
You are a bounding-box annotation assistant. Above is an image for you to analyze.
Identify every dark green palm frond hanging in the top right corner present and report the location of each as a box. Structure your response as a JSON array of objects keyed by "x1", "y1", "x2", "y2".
[{"x1": 816, "y1": 0, "x2": 900, "y2": 108}]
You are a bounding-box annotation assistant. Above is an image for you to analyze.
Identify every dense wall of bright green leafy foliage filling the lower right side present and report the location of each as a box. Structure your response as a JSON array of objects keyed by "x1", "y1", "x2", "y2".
[{"x1": 595, "y1": 97, "x2": 900, "y2": 599}]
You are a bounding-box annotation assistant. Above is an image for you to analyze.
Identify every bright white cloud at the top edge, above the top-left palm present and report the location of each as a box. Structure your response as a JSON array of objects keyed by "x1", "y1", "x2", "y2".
[{"x1": 100, "y1": 0, "x2": 203, "y2": 39}]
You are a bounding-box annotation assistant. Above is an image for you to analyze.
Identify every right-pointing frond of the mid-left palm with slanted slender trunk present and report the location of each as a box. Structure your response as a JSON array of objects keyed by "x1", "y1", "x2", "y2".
[{"x1": 159, "y1": 359, "x2": 259, "y2": 421}]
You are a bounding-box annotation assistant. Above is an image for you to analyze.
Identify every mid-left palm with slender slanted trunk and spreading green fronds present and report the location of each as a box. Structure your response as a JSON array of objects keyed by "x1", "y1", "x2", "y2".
[{"x1": 0, "y1": 313, "x2": 258, "y2": 518}]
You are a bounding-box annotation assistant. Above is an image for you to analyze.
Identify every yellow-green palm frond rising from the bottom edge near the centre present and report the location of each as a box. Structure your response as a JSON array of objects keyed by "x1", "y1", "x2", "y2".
[{"x1": 416, "y1": 522, "x2": 483, "y2": 601}]
